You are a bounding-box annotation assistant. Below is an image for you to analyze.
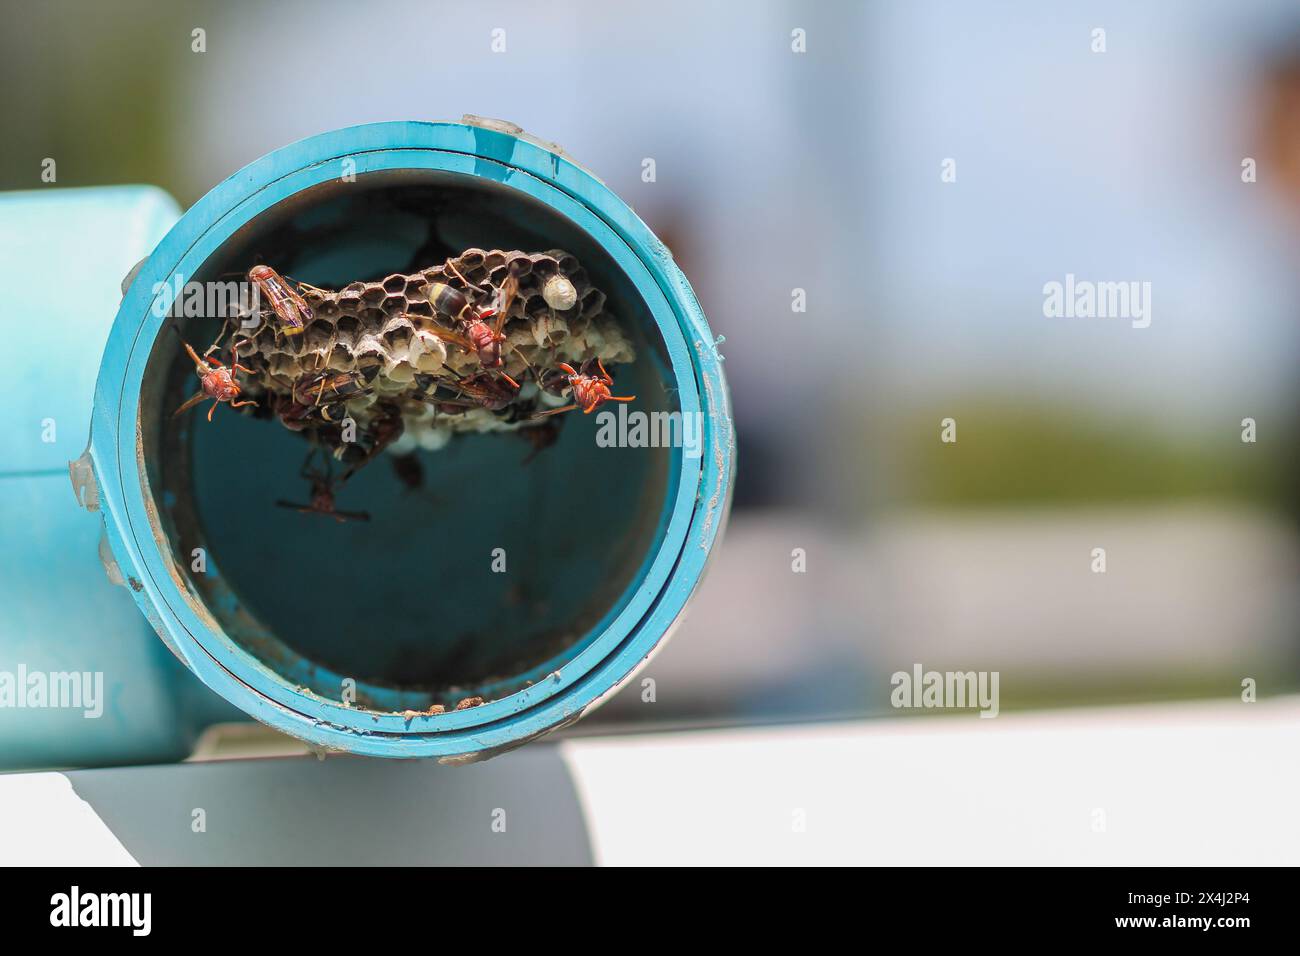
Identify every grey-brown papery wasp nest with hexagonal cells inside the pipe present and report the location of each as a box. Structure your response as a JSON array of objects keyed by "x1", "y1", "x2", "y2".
[{"x1": 237, "y1": 248, "x2": 636, "y2": 468}]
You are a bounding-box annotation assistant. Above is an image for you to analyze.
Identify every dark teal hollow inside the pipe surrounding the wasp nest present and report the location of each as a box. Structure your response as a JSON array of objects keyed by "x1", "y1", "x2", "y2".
[{"x1": 139, "y1": 170, "x2": 680, "y2": 711}]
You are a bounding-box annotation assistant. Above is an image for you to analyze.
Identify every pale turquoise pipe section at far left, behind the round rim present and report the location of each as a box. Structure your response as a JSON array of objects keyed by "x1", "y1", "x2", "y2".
[{"x1": 0, "y1": 186, "x2": 242, "y2": 771}]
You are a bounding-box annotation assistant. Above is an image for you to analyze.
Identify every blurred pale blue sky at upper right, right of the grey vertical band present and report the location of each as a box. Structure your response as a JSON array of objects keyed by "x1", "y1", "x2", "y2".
[{"x1": 866, "y1": 3, "x2": 1300, "y2": 420}]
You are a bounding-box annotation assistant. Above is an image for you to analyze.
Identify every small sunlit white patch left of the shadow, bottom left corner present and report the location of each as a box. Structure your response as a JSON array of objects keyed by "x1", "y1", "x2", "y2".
[{"x1": 0, "y1": 774, "x2": 137, "y2": 866}]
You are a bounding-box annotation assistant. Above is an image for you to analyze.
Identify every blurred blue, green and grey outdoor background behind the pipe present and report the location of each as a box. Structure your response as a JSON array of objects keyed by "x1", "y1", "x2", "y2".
[{"x1": 0, "y1": 0, "x2": 1300, "y2": 732}]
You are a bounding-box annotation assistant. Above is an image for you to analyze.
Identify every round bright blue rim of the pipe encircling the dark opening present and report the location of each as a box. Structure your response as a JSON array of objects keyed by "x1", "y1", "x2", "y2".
[{"x1": 91, "y1": 122, "x2": 735, "y2": 760}]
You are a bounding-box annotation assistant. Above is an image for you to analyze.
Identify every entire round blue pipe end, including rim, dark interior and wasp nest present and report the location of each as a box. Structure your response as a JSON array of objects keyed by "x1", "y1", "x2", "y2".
[{"x1": 81, "y1": 122, "x2": 733, "y2": 761}]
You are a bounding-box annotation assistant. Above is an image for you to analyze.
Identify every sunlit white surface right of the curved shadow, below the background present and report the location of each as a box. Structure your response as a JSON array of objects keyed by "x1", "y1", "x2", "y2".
[{"x1": 563, "y1": 698, "x2": 1300, "y2": 866}]
